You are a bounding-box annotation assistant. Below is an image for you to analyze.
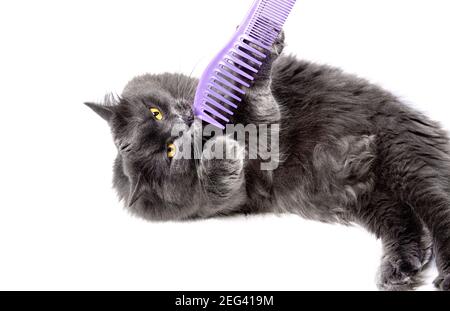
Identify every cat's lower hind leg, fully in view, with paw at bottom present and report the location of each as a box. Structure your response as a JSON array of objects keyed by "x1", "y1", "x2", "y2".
[{"x1": 361, "y1": 192, "x2": 432, "y2": 290}]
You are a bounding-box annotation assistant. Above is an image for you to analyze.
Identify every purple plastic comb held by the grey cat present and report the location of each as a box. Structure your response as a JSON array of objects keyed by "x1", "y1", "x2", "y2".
[{"x1": 194, "y1": 0, "x2": 296, "y2": 129}]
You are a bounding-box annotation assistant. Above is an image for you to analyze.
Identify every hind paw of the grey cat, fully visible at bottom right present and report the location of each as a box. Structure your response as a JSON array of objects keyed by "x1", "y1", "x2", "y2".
[{"x1": 377, "y1": 257, "x2": 423, "y2": 291}]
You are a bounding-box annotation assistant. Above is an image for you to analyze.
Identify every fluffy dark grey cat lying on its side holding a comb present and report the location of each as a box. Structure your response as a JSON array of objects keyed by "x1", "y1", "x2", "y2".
[{"x1": 87, "y1": 36, "x2": 450, "y2": 290}]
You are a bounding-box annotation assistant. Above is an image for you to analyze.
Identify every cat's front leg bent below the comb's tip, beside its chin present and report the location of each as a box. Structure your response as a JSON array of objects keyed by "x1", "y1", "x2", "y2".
[{"x1": 198, "y1": 136, "x2": 246, "y2": 216}]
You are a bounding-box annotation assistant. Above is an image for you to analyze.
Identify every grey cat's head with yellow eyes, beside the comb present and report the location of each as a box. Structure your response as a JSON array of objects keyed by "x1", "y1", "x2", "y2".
[{"x1": 86, "y1": 74, "x2": 199, "y2": 220}]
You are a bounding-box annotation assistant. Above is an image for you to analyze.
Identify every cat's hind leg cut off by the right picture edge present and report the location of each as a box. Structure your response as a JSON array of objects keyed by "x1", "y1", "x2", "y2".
[{"x1": 377, "y1": 108, "x2": 450, "y2": 290}]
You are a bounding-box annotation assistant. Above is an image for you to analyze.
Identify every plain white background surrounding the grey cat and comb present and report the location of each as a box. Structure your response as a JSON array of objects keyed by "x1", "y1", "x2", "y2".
[{"x1": 0, "y1": 0, "x2": 450, "y2": 290}]
